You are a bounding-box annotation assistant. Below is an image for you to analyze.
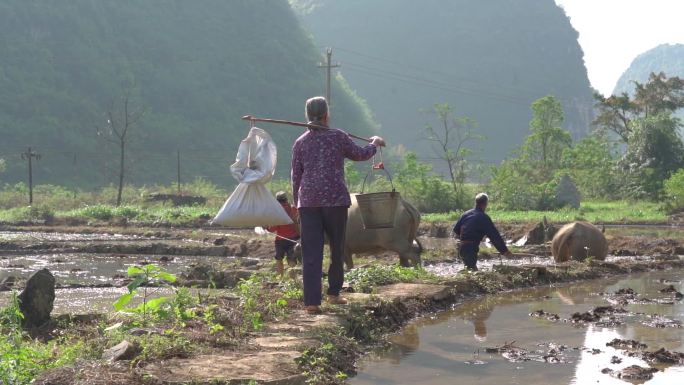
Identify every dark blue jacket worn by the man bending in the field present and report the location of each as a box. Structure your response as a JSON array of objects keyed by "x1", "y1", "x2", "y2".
[{"x1": 453, "y1": 207, "x2": 508, "y2": 253}]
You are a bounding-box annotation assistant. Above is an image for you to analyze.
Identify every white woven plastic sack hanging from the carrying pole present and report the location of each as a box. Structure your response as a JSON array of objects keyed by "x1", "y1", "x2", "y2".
[{"x1": 211, "y1": 127, "x2": 292, "y2": 227}]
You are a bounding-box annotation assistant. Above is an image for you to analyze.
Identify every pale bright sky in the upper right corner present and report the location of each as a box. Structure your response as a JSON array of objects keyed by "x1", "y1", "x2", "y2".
[{"x1": 556, "y1": 0, "x2": 684, "y2": 95}]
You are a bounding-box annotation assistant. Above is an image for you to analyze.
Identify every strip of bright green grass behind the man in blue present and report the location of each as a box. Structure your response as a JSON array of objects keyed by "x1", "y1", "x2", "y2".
[{"x1": 423, "y1": 201, "x2": 668, "y2": 223}]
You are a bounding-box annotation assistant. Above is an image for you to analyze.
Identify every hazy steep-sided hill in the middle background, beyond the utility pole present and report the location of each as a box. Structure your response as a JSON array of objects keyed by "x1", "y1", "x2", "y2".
[{"x1": 291, "y1": 0, "x2": 593, "y2": 160}]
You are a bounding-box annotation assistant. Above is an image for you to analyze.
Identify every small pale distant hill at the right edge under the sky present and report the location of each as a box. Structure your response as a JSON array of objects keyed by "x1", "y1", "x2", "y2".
[{"x1": 613, "y1": 44, "x2": 684, "y2": 94}]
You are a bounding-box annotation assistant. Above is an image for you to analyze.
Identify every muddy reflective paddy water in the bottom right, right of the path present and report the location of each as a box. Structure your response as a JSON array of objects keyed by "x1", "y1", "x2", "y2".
[{"x1": 350, "y1": 271, "x2": 684, "y2": 385}]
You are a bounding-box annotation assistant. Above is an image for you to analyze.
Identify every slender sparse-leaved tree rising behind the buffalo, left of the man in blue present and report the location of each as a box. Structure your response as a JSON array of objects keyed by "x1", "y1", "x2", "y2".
[{"x1": 425, "y1": 103, "x2": 483, "y2": 194}]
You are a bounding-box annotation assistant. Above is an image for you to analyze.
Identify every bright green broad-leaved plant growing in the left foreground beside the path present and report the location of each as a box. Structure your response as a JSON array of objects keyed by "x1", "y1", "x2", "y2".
[{"x1": 113, "y1": 264, "x2": 176, "y2": 324}]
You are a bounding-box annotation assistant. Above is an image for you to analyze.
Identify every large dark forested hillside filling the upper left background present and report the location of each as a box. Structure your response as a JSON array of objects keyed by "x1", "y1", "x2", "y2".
[{"x1": 0, "y1": 0, "x2": 375, "y2": 187}]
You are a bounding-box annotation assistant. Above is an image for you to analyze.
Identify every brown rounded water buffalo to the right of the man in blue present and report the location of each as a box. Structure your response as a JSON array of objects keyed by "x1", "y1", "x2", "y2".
[{"x1": 551, "y1": 222, "x2": 608, "y2": 262}]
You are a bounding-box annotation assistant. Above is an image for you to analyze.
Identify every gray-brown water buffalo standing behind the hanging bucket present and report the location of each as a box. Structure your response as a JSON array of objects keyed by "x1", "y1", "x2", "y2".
[{"x1": 344, "y1": 194, "x2": 422, "y2": 269}]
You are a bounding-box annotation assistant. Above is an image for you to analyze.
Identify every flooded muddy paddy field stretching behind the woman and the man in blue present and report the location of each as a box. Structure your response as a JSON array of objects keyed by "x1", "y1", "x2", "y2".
[{"x1": 0, "y1": 223, "x2": 684, "y2": 313}]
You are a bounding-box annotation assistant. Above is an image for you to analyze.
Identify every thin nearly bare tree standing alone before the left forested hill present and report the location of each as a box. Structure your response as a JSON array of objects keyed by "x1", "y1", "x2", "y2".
[{"x1": 97, "y1": 87, "x2": 145, "y2": 206}]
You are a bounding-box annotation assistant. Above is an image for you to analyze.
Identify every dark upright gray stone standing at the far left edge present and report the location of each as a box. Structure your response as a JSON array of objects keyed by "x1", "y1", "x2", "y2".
[{"x1": 19, "y1": 269, "x2": 55, "y2": 328}]
